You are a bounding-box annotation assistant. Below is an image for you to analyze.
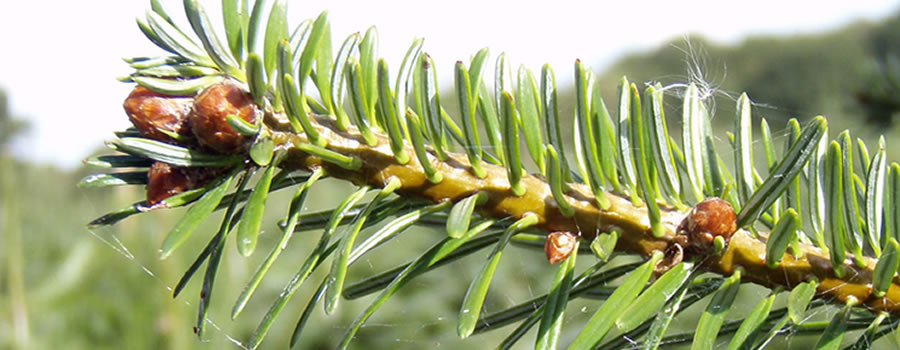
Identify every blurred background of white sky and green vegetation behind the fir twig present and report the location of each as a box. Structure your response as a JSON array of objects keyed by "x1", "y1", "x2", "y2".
[{"x1": 0, "y1": 1, "x2": 900, "y2": 349}]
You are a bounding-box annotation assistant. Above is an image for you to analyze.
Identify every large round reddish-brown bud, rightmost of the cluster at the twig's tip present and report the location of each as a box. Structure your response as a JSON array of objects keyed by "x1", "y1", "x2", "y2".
[{"x1": 190, "y1": 81, "x2": 258, "y2": 154}]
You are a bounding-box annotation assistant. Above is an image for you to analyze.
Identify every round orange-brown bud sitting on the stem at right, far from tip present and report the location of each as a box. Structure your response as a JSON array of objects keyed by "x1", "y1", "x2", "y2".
[{"x1": 678, "y1": 197, "x2": 737, "y2": 245}]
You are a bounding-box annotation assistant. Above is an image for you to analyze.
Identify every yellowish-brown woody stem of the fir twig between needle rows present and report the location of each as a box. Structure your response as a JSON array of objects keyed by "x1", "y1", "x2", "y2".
[{"x1": 267, "y1": 108, "x2": 900, "y2": 314}]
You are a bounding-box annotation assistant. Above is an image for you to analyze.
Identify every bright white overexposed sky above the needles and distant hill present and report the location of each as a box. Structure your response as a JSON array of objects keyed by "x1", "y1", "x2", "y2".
[{"x1": 0, "y1": 0, "x2": 900, "y2": 168}]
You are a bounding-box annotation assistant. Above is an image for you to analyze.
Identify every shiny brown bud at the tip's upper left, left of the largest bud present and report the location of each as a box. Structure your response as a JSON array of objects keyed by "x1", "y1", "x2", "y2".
[{"x1": 123, "y1": 86, "x2": 192, "y2": 142}]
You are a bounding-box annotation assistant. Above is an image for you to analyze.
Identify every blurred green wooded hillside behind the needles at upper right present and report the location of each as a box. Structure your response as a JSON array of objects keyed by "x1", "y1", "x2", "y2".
[{"x1": 601, "y1": 11, "x2": 900, "y2": 132}]
